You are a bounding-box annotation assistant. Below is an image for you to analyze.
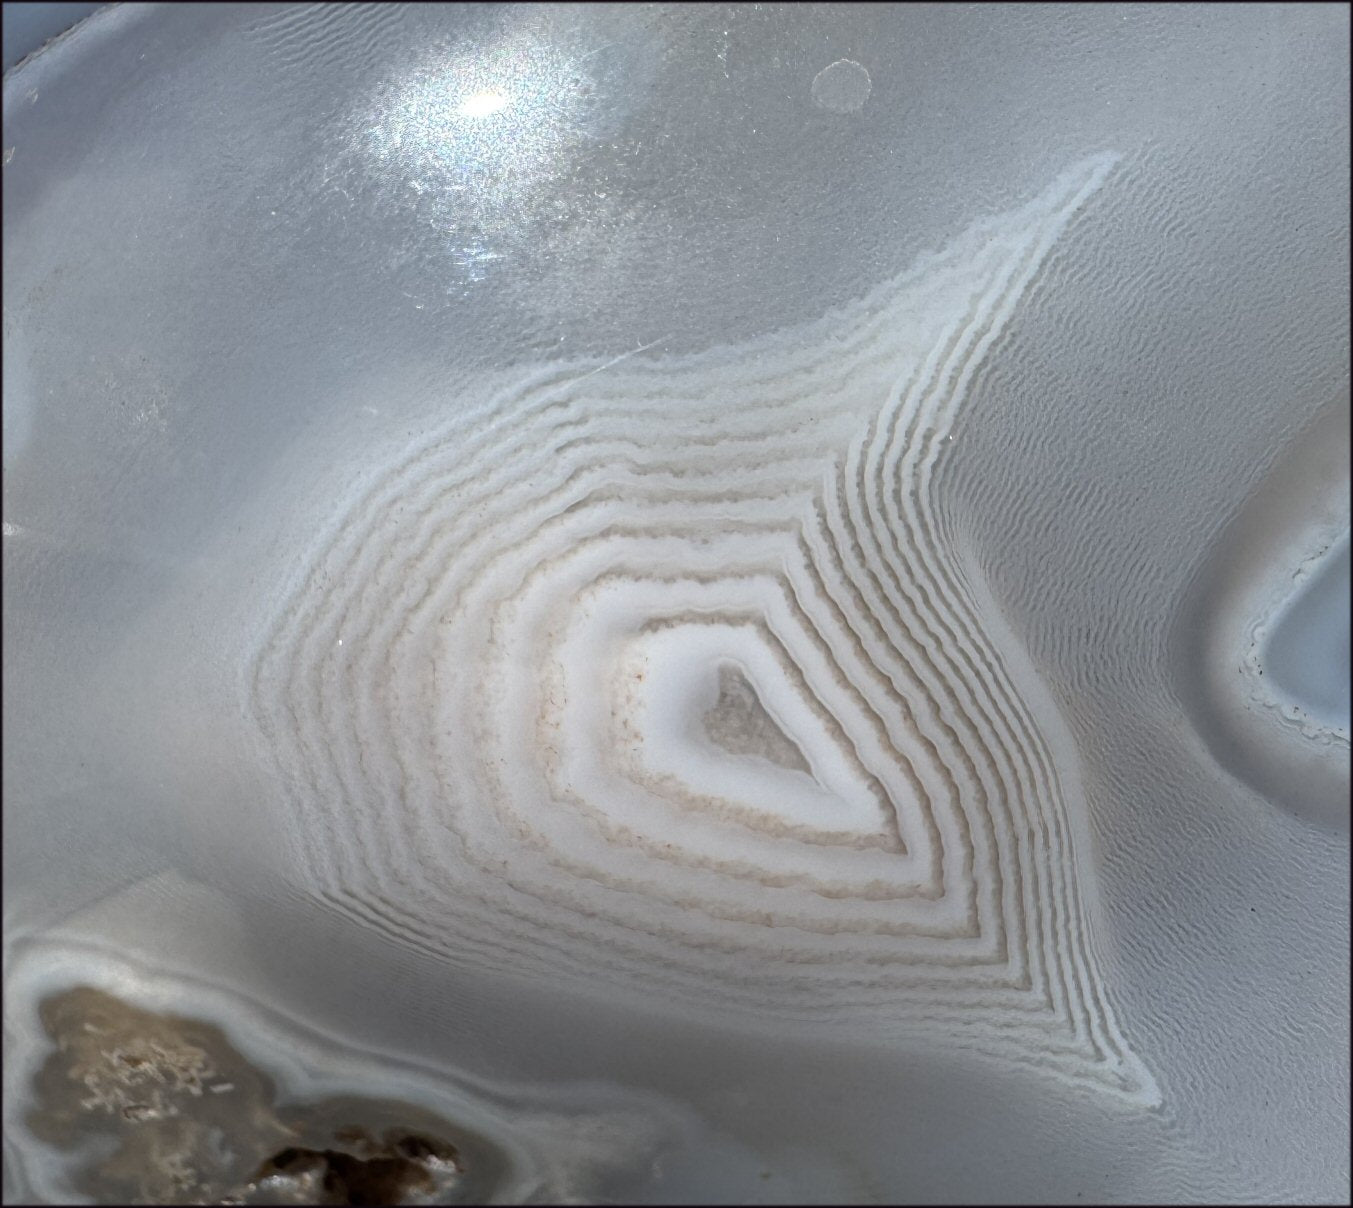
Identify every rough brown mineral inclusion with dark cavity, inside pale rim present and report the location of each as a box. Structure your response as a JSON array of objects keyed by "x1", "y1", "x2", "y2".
[{"x1": 27, "y1": 986, "x2": 505, "y2": 1205}]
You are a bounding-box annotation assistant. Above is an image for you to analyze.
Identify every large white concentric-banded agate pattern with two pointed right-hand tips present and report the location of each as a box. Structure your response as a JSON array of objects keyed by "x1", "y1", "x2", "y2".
[{"x1": 250, "y1": 157, "x2": 1155, "y2": 1101}]
